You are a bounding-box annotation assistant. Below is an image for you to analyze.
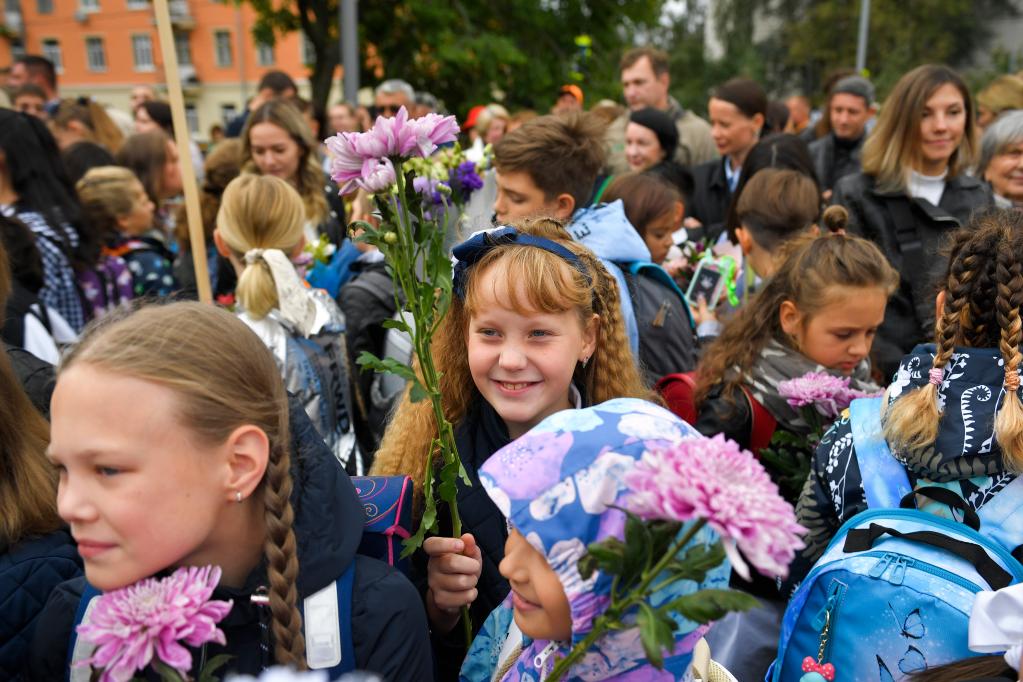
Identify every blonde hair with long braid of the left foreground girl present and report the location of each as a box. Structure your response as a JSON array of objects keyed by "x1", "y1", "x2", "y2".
[{"x1": 60, "y1": 303, "x2": 305, "y2": 669}]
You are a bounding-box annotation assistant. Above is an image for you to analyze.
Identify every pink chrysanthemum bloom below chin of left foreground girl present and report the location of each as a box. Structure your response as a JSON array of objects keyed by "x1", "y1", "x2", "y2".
[{"x1": 78, "y1": 566, "x2": 231, "y2": 682}]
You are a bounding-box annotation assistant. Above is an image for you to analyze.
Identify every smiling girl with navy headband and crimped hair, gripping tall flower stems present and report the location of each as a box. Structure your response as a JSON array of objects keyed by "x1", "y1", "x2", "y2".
[{"x1": 372, "y1": 218, "x2": 649, "y2": 680}]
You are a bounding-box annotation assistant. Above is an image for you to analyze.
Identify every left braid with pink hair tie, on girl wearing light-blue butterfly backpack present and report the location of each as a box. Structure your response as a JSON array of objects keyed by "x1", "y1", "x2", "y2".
[{"x1": 884, "y1": 240, "x2": 979, "y2": 450}]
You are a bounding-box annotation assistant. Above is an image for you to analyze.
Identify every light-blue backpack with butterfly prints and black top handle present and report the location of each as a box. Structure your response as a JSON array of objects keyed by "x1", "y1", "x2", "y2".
[{"x1": 767, "y1": 398, "x2": 1023, "y2": 682}]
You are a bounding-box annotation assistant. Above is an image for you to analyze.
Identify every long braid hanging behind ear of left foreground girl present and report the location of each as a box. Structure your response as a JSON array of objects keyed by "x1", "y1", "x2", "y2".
[{"x1": 263, "y1": 433, "x2": 306, "y2": 670}]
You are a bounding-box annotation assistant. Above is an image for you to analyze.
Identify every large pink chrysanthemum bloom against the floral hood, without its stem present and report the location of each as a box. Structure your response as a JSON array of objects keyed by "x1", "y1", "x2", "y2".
[{"x1": 625, "y1": 435, "x2": 806, "y2": 580}]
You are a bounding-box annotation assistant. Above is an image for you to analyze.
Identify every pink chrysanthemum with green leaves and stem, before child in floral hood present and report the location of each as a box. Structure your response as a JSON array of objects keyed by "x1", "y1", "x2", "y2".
[{"x1": 548, "y1": 436, "x2": 805, "y2": 680}]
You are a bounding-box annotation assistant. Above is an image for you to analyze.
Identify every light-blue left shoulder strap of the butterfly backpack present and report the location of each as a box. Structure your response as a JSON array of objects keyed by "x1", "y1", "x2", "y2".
[{"x1": 849, "y1": 398, "x2": 913, "y2": 509}]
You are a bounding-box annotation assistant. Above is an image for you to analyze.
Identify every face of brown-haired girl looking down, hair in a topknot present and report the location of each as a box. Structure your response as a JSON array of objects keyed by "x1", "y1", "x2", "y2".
[{"x1": 781, "y1": 286, "x2": 888, "y2": 374}]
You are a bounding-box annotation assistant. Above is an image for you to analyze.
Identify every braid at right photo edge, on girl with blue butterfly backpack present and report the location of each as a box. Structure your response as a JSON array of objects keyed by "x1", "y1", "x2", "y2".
[{"x1": 994, "y1": 234, "x2": 1023, "y2": 470}]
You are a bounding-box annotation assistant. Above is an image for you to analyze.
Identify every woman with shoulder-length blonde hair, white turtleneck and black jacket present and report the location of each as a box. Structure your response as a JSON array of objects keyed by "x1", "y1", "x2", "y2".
[{"x1": 833, "y1": 64, "x2": 992, "y2": 376}]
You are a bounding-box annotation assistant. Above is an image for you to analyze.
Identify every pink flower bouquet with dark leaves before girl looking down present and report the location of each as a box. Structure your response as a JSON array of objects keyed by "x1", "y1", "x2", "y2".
[{"x1": 760, "y1": 372, "x2": 874, "y2": 499}]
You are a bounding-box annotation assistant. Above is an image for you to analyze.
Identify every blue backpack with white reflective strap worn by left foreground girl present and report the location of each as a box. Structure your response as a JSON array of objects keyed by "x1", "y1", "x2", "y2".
[{"x1": 65, "y1": 476, "x2": 412, "y2": 682}]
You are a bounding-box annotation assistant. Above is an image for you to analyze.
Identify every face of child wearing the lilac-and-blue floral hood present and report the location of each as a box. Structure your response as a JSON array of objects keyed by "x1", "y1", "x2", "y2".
[{"x1": 499, "y1": 529, "x2": 572, "y2": 642}]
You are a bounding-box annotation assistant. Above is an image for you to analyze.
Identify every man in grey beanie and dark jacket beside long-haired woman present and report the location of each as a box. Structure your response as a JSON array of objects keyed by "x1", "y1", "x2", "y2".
[{"x1": 810, "y1": 76, "x2": 877, "y2": 194}]
